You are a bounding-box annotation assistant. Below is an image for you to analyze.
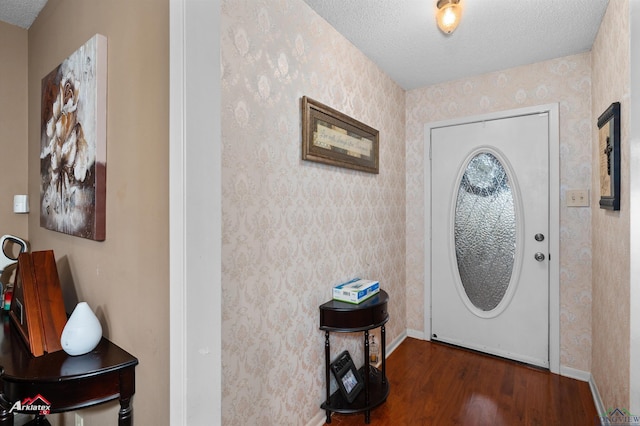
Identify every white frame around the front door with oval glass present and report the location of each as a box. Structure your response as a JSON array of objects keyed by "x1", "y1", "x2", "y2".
[{"x1": 423, "y1": 103, "x2": 560, "y2": 374}]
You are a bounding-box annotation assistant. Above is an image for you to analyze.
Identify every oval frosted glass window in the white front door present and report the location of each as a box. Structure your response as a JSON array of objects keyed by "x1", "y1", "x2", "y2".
[{"x1": 453, "y1": 152, "x2": 516, "y2": 312}]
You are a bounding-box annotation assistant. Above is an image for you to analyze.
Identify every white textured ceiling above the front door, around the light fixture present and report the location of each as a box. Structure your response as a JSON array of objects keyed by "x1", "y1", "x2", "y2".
[{"x1": 304, "y1": 0, "x2": 608, "y2": 90}]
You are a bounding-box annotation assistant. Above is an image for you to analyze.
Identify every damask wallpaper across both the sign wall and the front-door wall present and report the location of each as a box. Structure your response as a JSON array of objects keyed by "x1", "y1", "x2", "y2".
[{"x1": 221, "y1": 0, "x2": 616, "y2": 425}]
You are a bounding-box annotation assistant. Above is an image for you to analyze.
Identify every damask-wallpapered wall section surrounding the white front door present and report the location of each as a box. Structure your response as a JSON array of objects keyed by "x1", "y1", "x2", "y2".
[{"x1": 406, "y1": 53, "x2": 597, "y2": 371}]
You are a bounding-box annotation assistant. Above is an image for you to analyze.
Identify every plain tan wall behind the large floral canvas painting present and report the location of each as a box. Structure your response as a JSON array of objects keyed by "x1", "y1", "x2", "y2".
[{"x1": 24, "y1": 0, "x2": 169, "y2": 425}]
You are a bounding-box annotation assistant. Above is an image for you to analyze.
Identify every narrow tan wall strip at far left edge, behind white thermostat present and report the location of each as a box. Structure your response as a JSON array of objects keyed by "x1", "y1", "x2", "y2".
[{"x1": 0, "y1": 22, "x2": 28, "y2": 243}]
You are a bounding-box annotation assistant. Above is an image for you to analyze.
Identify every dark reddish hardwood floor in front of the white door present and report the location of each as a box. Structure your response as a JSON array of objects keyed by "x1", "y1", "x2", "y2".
[{"x1": 332, "y1": 338, "x2": 599, "y2": 426}]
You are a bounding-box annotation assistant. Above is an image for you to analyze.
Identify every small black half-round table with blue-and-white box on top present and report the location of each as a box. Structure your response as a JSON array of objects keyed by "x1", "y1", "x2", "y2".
[{"x1": 320, "y1": 290, "x2": 389, "y2": 424}]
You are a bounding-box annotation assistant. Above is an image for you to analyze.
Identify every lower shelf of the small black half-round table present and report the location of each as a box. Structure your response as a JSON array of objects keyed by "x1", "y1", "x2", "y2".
[{"x1": 320, "y1": 366, "x2": 389, "y2": 414}]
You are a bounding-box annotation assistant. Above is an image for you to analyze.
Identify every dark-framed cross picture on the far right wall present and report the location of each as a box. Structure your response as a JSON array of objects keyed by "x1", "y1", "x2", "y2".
[{"x1": 598, "y1": 102, "x2": 620, "y2": 210}]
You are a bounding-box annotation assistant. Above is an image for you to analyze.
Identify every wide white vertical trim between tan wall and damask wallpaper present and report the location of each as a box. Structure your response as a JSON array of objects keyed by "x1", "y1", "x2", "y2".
[{"x1": 170, "y1": 0, "x2": 222, "y2": 426}]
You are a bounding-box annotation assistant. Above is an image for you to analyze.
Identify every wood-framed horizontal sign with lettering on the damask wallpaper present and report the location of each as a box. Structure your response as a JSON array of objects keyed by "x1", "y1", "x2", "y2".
[{"x1": 302, "y1": 96, "x2": 379, "y2": 174}]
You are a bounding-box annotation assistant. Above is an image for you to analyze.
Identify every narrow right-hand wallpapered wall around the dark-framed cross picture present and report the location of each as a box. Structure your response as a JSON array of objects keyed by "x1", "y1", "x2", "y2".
[{"x1": 591, "y1": 0, "x2": 630, "y2": 409}]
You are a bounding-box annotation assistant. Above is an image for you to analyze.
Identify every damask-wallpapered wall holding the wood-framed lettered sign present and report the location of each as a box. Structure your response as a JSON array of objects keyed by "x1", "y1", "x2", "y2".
[{"x1": 220, "y1": 0, "x2": 406, "y2": 425}]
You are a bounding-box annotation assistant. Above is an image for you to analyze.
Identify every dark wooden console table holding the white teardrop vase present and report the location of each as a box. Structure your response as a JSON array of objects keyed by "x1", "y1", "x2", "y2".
[{"x1": 0, "y1": 313, "x2": 138, "y2": 426}]
